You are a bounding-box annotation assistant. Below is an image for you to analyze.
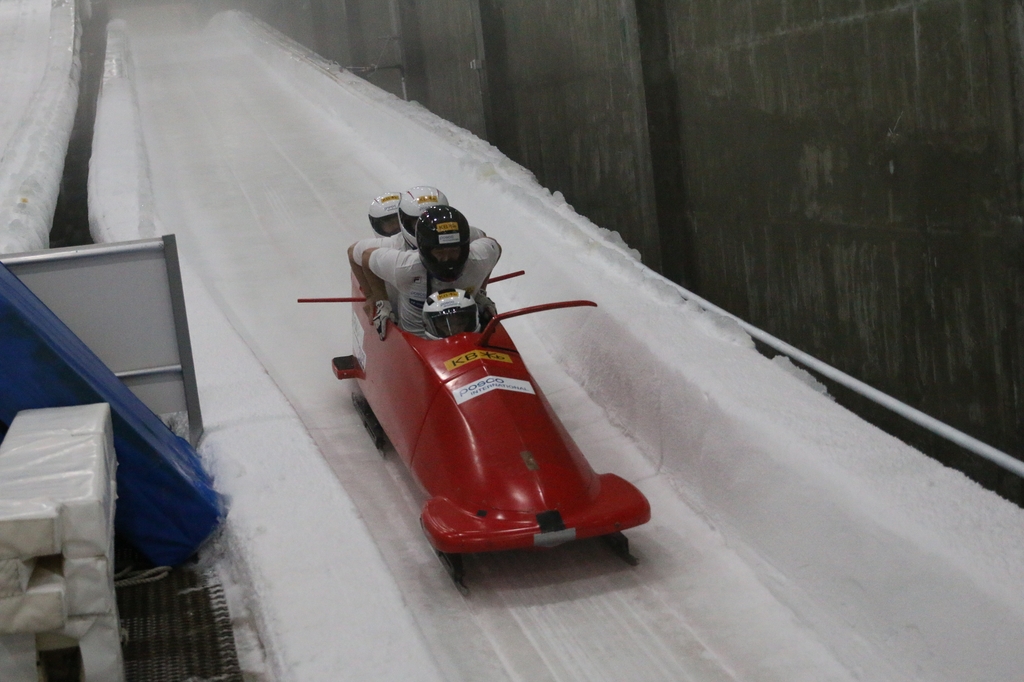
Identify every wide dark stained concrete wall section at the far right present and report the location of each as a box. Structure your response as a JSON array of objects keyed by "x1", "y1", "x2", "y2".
[{"x1": 665, "y1": 0, "x2": 1024, "y2": 495}]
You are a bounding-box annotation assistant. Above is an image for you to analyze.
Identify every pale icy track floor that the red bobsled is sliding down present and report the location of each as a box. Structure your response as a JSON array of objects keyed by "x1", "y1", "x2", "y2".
[{"x1": 83, "y1": 5, "x2": 1024, "y2": 682}]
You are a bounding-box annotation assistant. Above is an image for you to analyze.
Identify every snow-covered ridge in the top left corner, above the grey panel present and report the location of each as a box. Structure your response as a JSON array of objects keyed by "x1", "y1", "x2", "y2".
[{"x1": 0, "y1": 0, "x2": 83, "y2": 253}]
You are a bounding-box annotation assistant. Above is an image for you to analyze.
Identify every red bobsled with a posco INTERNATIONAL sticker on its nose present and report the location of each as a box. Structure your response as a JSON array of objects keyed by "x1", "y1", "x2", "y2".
[{"x1": 323, "y1": 278, "x2": 650, "y2": 590}]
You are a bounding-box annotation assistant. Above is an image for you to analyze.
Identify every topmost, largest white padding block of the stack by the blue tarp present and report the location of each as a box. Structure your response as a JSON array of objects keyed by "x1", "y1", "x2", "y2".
[{"x1": 0, "y1": 403, "x2": 115, "y2": 558}]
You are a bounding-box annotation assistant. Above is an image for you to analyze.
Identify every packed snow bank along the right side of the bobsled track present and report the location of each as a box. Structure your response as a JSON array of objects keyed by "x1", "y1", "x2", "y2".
[{"x1": 205, "y1": 13, "x2": 1024, "y2": 681}]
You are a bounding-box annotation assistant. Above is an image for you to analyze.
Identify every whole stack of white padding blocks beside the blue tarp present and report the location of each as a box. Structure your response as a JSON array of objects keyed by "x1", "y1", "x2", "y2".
[{"x1": 0, "y1": 403, "x2": 124, "y2": 682}]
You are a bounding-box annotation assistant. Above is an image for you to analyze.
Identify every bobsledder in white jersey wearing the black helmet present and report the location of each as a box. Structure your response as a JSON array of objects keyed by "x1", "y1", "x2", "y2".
[{"x1": 362, "y1": 206, "x2": 502, "y2": 338}]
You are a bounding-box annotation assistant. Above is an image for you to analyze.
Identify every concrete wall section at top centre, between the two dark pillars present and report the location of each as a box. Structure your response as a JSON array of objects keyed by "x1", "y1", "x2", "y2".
[{"x1": 479, "y1": 0, "x2": 662, "y2": 269}]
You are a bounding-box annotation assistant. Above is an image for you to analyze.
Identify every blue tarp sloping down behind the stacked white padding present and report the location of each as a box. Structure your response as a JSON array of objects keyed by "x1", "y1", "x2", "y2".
[{"x1": 0, "y1": 259, "x2": 225, "y2": 566}]
